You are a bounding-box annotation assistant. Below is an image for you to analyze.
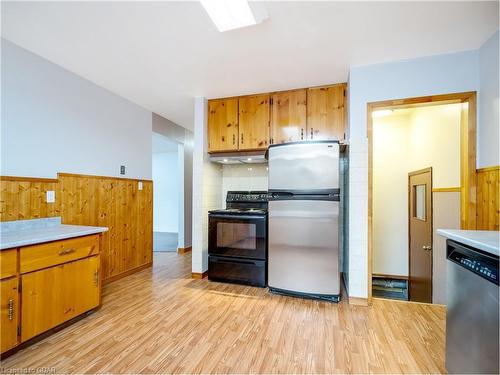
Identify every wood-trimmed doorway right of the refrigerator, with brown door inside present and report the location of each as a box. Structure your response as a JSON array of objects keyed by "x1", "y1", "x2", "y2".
[{"x1": 367, "y1": 92, "x2": 476, "y2": 304}]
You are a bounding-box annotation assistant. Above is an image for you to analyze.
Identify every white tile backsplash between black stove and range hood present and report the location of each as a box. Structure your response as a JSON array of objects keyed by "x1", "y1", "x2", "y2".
[{"x1": 222, "y1": 164, "x2": 267, "y2": 206}]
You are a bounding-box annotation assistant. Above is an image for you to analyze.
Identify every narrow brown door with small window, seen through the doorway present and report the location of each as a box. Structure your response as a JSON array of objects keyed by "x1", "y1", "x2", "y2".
[{"x1": 408, "y1": 168, "x2": 432, "y2": 303}]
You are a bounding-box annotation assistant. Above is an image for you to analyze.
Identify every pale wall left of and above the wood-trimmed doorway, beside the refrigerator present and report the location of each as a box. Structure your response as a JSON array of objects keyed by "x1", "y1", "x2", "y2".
[{"x1": 348, "y1": 51, "x2": 479, "y2": 298}]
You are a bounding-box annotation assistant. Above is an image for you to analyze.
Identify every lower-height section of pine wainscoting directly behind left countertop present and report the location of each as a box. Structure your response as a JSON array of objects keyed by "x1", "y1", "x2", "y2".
[{"x1": 0, "y1": 176, "x2": 60, "y2": 221}]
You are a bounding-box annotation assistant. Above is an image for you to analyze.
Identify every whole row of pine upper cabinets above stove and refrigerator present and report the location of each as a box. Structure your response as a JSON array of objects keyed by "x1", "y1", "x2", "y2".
[{"x1": 208, "y1": 83, "x2": 347, "y2": 153}]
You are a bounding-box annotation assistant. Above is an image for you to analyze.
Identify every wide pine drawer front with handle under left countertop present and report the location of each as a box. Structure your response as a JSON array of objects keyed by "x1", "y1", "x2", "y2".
[{"x1": 20, "y1": 234, "x2": 99, "y2": 273}]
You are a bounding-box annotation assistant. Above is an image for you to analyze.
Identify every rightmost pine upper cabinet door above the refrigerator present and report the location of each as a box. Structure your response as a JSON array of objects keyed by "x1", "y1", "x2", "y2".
[{"x1": 307, "y1": 84, "x2": 346, "y2": 140}]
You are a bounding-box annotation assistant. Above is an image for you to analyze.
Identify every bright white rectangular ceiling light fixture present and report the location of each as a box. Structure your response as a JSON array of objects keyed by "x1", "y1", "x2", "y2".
[{"x1": 200, "y1": 0, "x2": 266, "y2": 32}]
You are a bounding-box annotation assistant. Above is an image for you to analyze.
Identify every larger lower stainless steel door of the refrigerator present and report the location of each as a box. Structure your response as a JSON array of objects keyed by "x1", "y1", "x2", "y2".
[{"x1": 268, "y1": 200, "x2": 340, "y2": 295}]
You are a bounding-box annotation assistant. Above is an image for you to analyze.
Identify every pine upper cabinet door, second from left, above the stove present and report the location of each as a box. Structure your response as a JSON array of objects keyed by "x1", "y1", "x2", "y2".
[{"x1": 238, "y1": 94, "x2": 269, "y2": 150}]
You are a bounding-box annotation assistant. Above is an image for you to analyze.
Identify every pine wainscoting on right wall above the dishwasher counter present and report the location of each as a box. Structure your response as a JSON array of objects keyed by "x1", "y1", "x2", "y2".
[{"x1": 476, "y1": 166, "x2": 500, "y2": 230}]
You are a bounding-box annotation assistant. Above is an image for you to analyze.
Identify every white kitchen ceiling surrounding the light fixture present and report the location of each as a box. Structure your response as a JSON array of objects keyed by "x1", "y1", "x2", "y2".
[{"x1": 2, "y1": 1, "x2": 498, "y2": 129}]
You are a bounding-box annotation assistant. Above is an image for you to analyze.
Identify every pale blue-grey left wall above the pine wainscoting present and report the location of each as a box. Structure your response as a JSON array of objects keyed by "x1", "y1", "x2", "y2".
[{"x1": 1, "y1": 39, "x2": 151, "y2": 179}]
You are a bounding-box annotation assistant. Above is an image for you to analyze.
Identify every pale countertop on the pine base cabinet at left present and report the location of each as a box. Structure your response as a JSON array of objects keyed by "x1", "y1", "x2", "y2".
[{"x1": 0, "y1": 219, "x2": 108, "y2": 250}]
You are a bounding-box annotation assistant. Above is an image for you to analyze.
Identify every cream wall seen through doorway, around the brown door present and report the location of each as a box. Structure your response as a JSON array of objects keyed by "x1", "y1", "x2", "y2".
[{"x1": 373, "y1": 104, "x2": 461, "y2": 276}]
